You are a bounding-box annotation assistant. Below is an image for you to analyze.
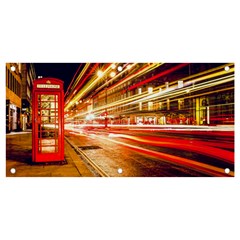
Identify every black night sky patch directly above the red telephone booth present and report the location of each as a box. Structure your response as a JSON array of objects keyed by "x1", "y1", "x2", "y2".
[{"x1": 34, "y1": 63, "x2": 80, "y2": 92}]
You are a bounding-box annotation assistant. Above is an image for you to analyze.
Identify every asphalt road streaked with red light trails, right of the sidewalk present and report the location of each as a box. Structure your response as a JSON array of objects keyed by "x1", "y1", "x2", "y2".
[{"x1": 65, "y1": 125, "x2": 234, "y2": 177}]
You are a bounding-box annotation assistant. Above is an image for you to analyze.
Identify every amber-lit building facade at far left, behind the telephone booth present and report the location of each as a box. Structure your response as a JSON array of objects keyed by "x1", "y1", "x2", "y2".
[{"x1": 6, "y1": 63, "x2": 36, "y2": 133}]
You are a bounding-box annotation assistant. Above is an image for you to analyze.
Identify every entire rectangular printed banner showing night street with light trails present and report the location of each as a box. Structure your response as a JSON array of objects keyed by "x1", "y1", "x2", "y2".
[{"x1": 6, "y1": 63, "x2": 234, "y2": 177}]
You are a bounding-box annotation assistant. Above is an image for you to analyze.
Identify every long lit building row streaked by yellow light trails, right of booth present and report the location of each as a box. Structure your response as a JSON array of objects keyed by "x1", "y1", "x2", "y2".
[{"x1": 63, "y1": 63, "x2": 234, "y2": 125}]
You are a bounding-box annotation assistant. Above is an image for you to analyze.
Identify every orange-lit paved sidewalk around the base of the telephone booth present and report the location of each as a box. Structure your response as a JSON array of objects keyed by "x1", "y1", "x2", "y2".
[{"x1": 6, "y1": 131, "x2": 94, "y2": 177}]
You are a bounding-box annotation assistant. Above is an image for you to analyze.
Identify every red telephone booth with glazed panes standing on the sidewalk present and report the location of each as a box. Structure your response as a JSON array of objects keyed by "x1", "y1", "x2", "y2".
[{"x1": 32, "y1": 78, "x2": 64, "y2": 162}]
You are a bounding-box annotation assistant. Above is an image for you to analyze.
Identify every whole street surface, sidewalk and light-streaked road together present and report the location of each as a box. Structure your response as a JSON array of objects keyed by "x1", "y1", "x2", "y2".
[{"x1": 7, "y1": 125, "x2": 234, "y2": 177}]
